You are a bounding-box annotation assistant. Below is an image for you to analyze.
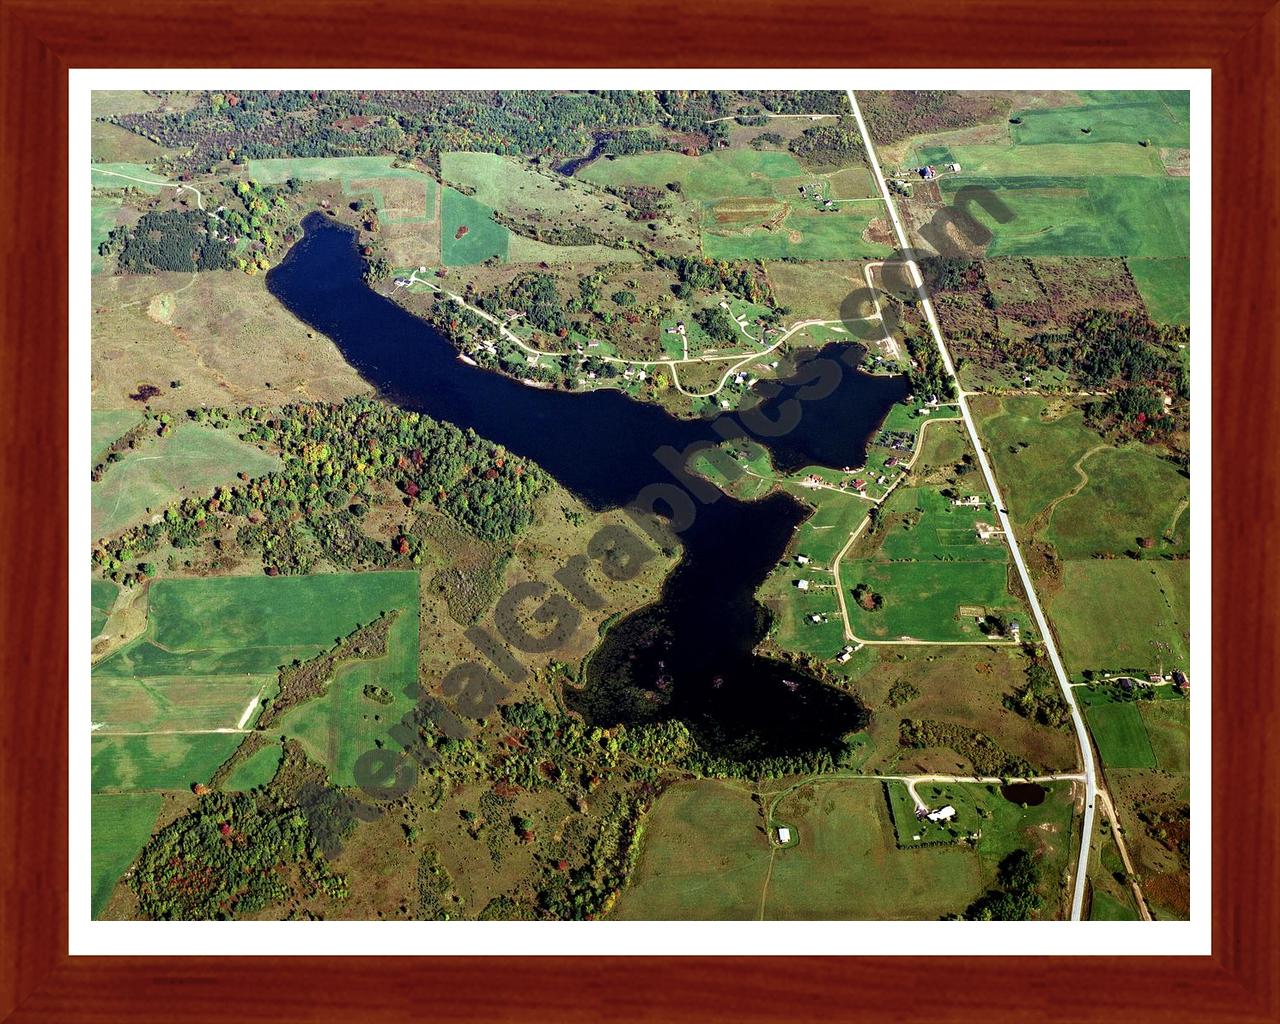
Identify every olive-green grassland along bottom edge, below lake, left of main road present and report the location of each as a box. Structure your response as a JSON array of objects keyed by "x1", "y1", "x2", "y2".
[{"x1": 613, "y1": 778, "x2": 1071, "y2": 920}]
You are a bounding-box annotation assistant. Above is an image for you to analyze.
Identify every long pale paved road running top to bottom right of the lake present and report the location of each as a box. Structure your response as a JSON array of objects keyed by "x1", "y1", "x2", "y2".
[{"x1": 849, "y1": 90, "x2": 1098, "y2": 920}]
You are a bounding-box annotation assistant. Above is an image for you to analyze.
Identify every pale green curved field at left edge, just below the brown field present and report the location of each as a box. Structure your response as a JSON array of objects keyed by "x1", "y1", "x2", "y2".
[{"x1": 90, "y1": 416, "x2": 280, "y2": 538}]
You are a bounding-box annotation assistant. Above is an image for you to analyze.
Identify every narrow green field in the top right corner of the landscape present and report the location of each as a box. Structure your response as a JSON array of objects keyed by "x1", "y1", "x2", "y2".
[{"x1": 1012, "y1": 90, "x2": 1190, "y2": 147}]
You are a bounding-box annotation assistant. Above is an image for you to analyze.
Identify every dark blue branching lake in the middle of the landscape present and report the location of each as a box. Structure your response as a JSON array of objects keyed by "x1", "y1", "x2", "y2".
[{"x1": 268, "y1": 214, "x2": 906, "y2": 754}]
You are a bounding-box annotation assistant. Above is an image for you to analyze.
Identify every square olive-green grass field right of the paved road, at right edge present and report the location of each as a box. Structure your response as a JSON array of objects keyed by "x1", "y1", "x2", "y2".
[{"x1": 1048, "y1": 558, "x2": 1190, "y2": 672}]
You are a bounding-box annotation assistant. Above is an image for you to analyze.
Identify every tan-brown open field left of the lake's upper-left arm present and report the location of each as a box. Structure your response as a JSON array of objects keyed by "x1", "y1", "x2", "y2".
[{"x1": 92, "y1": 271, "x2": 369, "y2": 412}]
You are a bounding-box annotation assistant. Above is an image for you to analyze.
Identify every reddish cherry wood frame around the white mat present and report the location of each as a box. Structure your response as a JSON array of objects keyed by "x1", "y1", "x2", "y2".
[{"x1": 0, "y1": 0, "x2": 1280, "y2": 1024}]
